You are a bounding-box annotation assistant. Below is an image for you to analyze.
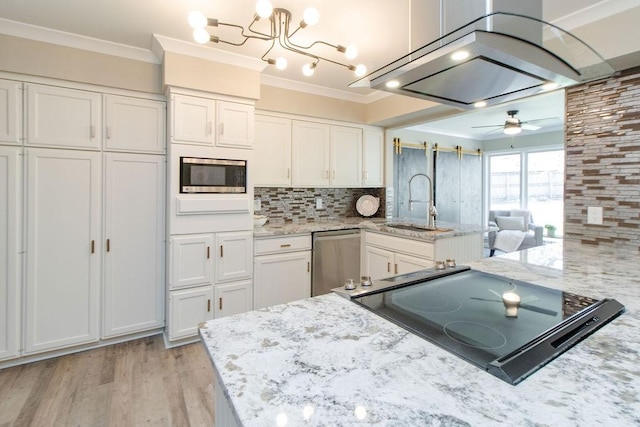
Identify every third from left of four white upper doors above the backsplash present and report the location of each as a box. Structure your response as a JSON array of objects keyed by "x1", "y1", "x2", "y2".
[{"x1": 330, "y1": 126, "x2": 362, "y2": 187}]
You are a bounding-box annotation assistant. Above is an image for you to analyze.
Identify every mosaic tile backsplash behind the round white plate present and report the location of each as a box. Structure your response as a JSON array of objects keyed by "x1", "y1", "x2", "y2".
[{"x1": 254, "y1": 187, "x2": 386, "y2": 224}]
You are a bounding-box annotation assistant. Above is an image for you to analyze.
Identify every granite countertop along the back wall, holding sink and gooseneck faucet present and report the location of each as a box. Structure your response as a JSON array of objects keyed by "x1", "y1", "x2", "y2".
[{"x1": 253, "y1": 217, "x2": 486, "y2": 241}]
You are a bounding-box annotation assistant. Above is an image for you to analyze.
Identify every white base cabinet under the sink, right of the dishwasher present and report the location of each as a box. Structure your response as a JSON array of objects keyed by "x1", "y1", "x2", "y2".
[{"x1": 364, "y1": 232, "x2": 434, "y2": 280}]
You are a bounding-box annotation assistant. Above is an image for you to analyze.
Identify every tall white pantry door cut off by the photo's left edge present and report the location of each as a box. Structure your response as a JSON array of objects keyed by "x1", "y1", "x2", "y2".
[{"x1": 0, "y1": 146, "x2": 22, "y2": 360}]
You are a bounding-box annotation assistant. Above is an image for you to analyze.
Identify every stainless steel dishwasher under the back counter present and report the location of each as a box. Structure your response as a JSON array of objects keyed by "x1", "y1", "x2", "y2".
[{"x1": 311, "y1": 229, "x2": 360, "y2": 296}]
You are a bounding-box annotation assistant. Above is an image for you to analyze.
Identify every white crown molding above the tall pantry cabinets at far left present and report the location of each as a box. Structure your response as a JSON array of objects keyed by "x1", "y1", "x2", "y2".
[{"x1": 0, "y1": 18, "x2": 160, "y2": 64}]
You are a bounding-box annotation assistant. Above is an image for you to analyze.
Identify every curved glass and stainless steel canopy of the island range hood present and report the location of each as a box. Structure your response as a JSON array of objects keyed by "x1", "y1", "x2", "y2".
[{"x1": 350, "y1": 12, "x2": 614, "y2": 109}]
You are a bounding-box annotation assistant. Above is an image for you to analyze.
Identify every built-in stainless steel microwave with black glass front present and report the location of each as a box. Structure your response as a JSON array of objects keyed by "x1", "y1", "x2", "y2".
[{"x1": 180, "y1": 157, "x2": 247, "y2": 193}]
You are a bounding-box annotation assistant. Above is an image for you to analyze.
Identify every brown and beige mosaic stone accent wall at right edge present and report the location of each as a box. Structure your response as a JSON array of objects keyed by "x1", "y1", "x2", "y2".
[{"x1": 564, "y1": 67, "x2": 640, "y2": 252}]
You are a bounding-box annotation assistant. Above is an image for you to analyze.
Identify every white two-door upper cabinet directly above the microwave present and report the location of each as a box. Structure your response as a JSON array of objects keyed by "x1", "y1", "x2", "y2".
[{"x1": 171, "y1": 94, "x2": 254, "y2": 149}]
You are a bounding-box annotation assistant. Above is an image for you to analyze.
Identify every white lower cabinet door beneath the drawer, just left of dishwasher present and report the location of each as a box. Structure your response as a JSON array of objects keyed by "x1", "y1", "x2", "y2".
[{"x1": 253, "y1": 251, "x2": 311, "y2": 309}]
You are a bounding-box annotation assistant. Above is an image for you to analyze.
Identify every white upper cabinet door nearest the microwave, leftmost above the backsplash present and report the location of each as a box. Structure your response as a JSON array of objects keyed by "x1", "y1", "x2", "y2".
[{"x1": 252, "y1": 114, "x2": 291, "y2": 187}]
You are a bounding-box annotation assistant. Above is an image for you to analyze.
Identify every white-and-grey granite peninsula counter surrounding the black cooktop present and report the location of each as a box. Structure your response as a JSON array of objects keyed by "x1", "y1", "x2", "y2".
[{"x1": 200, "y1": 242, "x2": 640, "y2": 426}]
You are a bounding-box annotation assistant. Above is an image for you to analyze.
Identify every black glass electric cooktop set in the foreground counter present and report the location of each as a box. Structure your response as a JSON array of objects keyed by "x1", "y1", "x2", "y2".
[{"x1": 352, "y1": 267, "x2": 624, "y2": 384}]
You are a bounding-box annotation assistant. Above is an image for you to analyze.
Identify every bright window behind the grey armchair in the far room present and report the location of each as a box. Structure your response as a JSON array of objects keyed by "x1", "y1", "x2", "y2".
[{"x1": 487, "y1": 149, "x2": 564, "y2": 235}]
